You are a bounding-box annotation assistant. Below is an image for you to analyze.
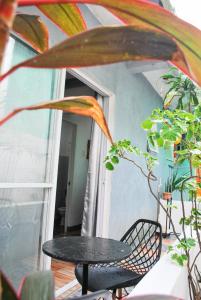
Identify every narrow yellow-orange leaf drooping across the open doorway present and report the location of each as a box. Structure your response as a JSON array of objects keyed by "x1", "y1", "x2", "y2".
[{"x1": 0, "y1": 96, "x2": 113, "y2": 143}]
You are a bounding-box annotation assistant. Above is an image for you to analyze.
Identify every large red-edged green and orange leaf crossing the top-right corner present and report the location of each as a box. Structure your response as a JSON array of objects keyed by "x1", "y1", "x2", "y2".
[{"x1": 16, "y1": 0, "x2": 201, "y2": 85}]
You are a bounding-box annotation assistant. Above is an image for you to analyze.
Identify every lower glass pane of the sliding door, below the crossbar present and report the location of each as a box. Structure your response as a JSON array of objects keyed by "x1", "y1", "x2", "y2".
[{"x1": 0, "y1": 188, "x2": 47, "y2": 287}]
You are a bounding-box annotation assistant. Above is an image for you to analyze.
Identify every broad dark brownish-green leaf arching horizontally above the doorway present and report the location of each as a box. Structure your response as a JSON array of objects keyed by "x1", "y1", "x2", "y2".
[{"x1": 0, "y1": 26, "x2": 183, "y2": 80}]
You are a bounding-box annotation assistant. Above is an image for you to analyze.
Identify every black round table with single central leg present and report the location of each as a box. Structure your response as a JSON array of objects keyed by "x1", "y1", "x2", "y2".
[{"x1": 43, "y1": 236, "x2": 131, "y2": 294}]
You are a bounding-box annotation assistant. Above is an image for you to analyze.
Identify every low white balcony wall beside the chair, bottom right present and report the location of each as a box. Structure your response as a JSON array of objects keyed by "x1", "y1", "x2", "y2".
[{"x1": 126, "y1": 241, "x2": 201, "y2": 300}]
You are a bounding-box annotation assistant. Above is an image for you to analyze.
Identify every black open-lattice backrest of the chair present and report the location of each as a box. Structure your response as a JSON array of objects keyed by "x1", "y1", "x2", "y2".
[{"x1": 121, "y1": 219, "x2": 162, "y2": 274}]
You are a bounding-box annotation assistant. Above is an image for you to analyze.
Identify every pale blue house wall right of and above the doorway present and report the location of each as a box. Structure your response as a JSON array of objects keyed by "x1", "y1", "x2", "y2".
[{"x1": 18, "y1": 8, "x2": 161, "y2": 238}]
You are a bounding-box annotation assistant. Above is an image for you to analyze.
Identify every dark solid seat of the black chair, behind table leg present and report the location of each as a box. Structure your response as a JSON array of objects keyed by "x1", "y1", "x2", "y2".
[{"x1": 75, "y1": 265, "x2": 143, "y2": 292}]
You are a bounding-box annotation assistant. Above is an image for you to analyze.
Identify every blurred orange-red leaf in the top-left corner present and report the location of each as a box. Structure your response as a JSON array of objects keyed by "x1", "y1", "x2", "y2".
[{"x1": 0, "y1": 0, "x2": 17, "y2": 67}]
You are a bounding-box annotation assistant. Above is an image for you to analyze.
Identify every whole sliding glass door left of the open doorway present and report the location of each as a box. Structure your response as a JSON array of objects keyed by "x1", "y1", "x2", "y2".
[{"x1": 0, "y1": 39, "x2": 62, "y2": 286}]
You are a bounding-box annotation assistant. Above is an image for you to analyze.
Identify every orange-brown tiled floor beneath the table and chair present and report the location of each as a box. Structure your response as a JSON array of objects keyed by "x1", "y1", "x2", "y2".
[{"x1": 52, "y1": 236, "x2": 175, "y2": 300}]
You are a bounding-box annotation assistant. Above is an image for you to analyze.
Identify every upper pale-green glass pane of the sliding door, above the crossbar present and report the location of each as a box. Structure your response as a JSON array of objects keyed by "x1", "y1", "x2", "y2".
[{"x1": 0, "y1": 40, "x2": 55, "y2": 183}]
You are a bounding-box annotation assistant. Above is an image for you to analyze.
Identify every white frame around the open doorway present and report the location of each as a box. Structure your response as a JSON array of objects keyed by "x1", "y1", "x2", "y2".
[{"x1": 42, "y1": 69, "x2": 115, "y2": 269}]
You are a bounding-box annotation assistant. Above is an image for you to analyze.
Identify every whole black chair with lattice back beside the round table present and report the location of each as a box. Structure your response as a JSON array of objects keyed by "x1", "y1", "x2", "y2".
[{"x1": 75, "y1": 219, "x2": 162, "y2": 292}]
